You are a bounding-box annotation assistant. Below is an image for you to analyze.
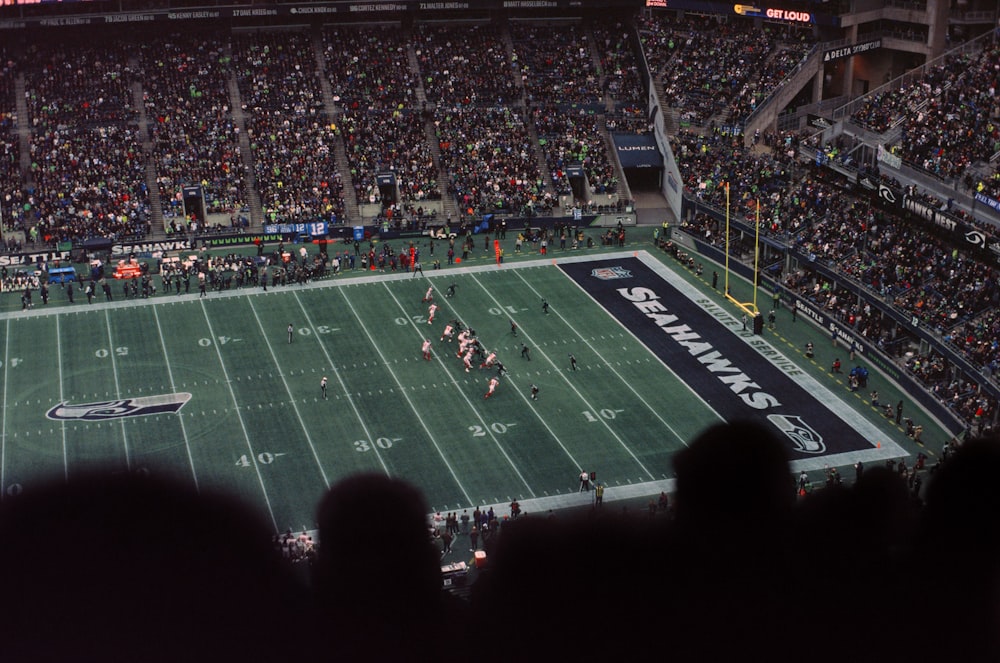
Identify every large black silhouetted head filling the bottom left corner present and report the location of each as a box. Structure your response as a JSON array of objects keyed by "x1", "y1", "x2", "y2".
[{"x1": 0, "y1": 475, "x2": 310, "y2": 662}]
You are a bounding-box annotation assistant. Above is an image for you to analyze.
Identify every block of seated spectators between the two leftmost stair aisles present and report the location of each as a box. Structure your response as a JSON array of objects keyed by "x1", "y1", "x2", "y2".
[{"x1": 22, "y1": 43, "x2": 151, "y2": 245}]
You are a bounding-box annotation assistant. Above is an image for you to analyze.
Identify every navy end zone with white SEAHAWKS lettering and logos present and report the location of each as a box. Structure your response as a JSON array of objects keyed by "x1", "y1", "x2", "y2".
[{"x1": 559, "y1": 257, "x2": 906, "y2": 467}]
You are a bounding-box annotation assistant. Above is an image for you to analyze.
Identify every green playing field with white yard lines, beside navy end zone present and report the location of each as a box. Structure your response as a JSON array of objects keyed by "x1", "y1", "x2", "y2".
[{"x1": 0, "y1": 245, "x2": 924, "y2": 531}]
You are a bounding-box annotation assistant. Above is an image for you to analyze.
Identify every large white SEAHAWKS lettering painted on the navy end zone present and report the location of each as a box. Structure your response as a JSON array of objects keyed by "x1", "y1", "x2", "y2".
[{"x1": 618, "y1": 288, "x2": 781, "y2": 410}]
